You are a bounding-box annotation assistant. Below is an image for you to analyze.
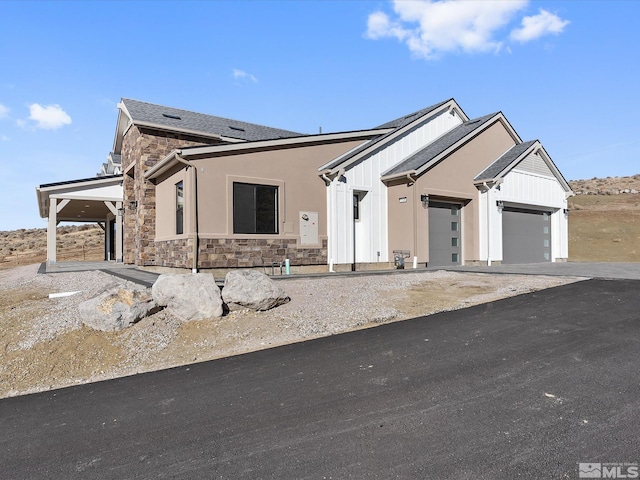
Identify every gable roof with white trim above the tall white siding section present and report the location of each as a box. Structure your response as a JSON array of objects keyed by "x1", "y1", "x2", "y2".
[{"x1": 318, "y1": 98, "x2": 468, "y2": 173}]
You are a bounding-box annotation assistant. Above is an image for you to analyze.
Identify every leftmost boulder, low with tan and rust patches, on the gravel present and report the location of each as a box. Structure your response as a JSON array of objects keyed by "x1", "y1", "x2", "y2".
[{"x1": 78, "y1": 287, "x2": 159, "y2": 332}]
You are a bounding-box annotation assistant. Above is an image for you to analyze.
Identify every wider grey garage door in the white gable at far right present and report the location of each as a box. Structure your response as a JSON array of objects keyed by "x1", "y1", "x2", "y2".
[{"x1": 502, "y1": 207, "x2": 551, "y2": 263}]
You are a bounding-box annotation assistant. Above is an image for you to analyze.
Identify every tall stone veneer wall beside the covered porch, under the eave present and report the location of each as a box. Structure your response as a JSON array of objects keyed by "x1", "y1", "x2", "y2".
[{"x1": 121, "y1": 126, "x2": 218, "y2": 265}]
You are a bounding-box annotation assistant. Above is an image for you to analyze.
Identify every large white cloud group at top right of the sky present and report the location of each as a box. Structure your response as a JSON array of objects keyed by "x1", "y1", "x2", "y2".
[{"x1": 365, "y1": 0, "x2": 568, "y2": 59}]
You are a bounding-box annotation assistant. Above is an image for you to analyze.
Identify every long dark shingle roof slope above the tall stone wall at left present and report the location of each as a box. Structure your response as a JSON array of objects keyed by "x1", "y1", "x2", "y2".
[{"x1": 122, "y1": 98, "x2": 302, "y2": 141}]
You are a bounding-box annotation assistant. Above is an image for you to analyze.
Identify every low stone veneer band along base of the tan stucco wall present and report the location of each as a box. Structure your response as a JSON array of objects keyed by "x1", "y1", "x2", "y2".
[{"x1": 156, "y1": 238, "x2": 327, "y2": 269}]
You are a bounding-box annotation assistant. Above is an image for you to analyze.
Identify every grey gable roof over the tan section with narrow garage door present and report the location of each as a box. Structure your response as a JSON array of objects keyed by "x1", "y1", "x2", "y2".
[{"x1": 382, "y1": 112, "x2": 504, "y2": 180}]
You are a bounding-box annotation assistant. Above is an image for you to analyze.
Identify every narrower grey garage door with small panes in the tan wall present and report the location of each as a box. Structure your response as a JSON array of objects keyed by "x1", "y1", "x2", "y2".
[{"x1": 429, "y1": 201, "x2": 462, "y2": 267}]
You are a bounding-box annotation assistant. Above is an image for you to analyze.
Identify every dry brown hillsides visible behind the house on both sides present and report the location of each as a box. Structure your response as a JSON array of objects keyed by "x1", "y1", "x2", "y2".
[{"x1": 0, "y1": 174, "x2": 640, "y2": 268}]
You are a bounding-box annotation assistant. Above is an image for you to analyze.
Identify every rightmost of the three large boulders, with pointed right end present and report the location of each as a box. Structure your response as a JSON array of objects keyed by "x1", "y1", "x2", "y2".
[{"x1": 222, "y1": 270, "x2": 290, "y2": 310}]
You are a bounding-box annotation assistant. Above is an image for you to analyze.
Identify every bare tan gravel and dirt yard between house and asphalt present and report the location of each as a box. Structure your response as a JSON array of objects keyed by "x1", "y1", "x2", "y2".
[{"x1": 0, "y1": 264, "x2": 579, "y2": 397}]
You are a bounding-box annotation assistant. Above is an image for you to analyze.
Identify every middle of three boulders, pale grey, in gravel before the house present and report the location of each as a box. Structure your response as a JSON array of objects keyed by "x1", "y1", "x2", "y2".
[{"x1": 151, "y1": 273, "x2": 223, "y2": 322}]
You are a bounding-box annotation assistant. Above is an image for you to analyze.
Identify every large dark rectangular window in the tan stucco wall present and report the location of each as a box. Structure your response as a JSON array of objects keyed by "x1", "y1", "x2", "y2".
[{"x1": 233, "y1": 182, "x2": 278, "y2": 234}]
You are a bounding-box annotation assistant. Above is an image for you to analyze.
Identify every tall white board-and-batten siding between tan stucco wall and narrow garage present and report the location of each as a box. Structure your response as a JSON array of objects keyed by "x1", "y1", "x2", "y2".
[{"x1": 327, "y1": 107, "x2": 462, "y2": 264}]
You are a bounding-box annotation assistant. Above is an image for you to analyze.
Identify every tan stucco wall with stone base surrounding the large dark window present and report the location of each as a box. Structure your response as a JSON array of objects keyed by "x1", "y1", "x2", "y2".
[{"x1": 155, "y1": 140, "x2": 362, "y2": 268}]
